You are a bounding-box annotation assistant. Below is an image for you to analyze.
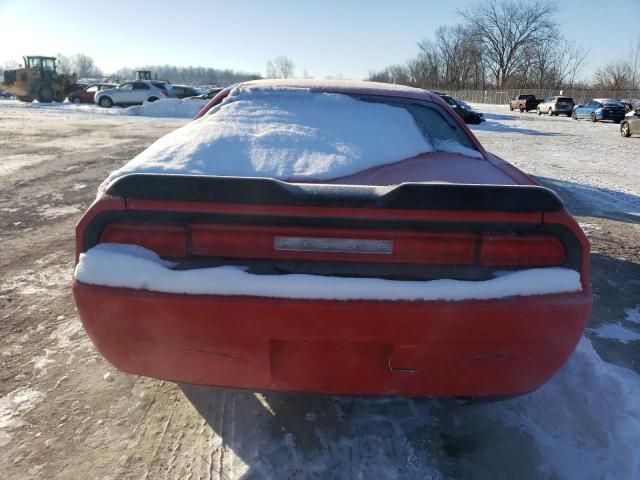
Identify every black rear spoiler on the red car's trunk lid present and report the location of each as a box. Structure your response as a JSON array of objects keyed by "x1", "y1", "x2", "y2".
[{"x1": 106, "y1": 174, "x2": 563, "y2": 212}]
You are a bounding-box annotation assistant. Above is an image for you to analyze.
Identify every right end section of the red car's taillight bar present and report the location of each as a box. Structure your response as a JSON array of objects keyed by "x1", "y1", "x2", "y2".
[{"x1": 480, "y1": 235, "x2": 565, "y2": 267}]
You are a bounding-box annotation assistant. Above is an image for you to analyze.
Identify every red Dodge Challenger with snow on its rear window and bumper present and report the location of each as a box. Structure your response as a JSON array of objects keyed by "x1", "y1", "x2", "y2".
[{"x1": 73, "y1": 80, "x2": 592, "y2": 397}]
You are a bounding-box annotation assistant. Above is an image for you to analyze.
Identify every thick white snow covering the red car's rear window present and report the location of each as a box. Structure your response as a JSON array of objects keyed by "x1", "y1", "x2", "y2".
[{"x1": 106, "y1": 86, "x2": 440, "y2": 185}]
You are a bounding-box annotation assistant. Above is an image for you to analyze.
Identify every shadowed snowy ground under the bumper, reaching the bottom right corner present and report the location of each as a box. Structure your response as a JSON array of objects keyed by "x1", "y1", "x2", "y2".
[{"x1": 171, "y1": 339, "x2": 640, "y2": 480}]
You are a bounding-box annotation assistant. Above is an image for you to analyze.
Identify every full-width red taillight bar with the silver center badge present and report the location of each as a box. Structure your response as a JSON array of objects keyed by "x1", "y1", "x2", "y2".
[{"x1": 95, "y1": 224, "x2": 565, "y2": 267}]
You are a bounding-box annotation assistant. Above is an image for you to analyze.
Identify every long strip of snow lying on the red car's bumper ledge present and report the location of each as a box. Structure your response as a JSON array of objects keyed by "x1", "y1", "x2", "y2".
[{"x1": 75, "y1": 243, "x2": 582, "y2": 300}]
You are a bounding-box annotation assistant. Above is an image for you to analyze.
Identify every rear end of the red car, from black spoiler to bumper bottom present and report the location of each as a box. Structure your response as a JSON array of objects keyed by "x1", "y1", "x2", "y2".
[{"x1": 73, "y1": 175, "x2": 591, "y2": 396}]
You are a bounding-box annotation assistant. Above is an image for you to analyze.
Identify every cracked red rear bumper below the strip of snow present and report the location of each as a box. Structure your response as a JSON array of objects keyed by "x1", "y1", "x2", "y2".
[{"x1": 73, "y1": 280, "x2": 591, "y2": 396}]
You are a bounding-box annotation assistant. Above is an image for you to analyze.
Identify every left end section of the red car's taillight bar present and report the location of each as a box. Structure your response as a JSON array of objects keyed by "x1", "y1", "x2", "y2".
[{"x1": 100, "y1": 223, "x2": 187, "y2": 257}]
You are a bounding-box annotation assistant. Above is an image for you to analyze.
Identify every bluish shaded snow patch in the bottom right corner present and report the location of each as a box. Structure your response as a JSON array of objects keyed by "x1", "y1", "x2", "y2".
[{"x1": 496, "y1": 338, "x2": 640, "y2": 479}]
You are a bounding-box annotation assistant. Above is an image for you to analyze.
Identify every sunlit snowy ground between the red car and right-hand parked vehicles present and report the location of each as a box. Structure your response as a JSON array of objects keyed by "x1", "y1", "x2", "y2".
[{"x1": 470, "y1": 104, "x2": 640, "y2": 216}]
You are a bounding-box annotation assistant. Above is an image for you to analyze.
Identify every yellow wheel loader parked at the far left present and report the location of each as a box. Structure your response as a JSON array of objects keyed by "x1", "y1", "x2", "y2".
[{"x1": 0, "y1": 57, "x2": 77, "y2": 103}]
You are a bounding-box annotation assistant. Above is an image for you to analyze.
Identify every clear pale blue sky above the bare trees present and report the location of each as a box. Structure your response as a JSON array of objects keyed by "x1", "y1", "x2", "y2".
[{"x1": 0, "y1": 0, "x2": 640, "y2": 79}]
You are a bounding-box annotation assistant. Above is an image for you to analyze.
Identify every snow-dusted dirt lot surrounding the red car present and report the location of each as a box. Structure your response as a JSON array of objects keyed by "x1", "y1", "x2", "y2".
[{"x1": 0, "y1": 102, "x2": 640, "y2": 479}]
